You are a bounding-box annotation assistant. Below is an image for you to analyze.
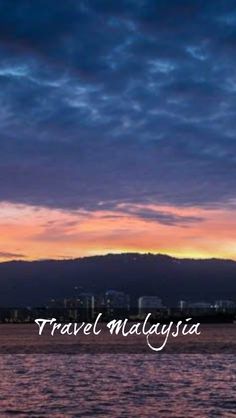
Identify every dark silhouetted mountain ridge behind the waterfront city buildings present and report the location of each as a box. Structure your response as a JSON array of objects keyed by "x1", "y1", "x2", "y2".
[{"x1": 0, "y1": 253, "x2": 236, "y2": 306}]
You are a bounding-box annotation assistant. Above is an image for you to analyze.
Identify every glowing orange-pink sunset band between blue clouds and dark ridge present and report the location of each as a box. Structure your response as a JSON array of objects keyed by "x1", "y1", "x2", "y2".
[{"x1": 0, "y1": 203, "x2": 236, "y2": 261}]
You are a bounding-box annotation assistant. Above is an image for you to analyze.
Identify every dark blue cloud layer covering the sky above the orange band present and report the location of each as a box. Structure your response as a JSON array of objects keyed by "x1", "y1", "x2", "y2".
[{"x1": 0, "y1": 0, "x2": 236, "y2": 222}]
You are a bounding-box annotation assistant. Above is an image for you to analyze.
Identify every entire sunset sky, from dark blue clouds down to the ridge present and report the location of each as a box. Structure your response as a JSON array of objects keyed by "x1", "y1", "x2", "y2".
[{"x1": 0, "y1": 0, "x2": 236, "y2": 261}]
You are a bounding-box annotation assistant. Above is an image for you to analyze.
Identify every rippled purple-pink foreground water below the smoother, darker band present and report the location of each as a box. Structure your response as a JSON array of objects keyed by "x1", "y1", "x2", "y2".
[{"x1": 0, "y1": 354, "x2": 236, "y2": 418}]
